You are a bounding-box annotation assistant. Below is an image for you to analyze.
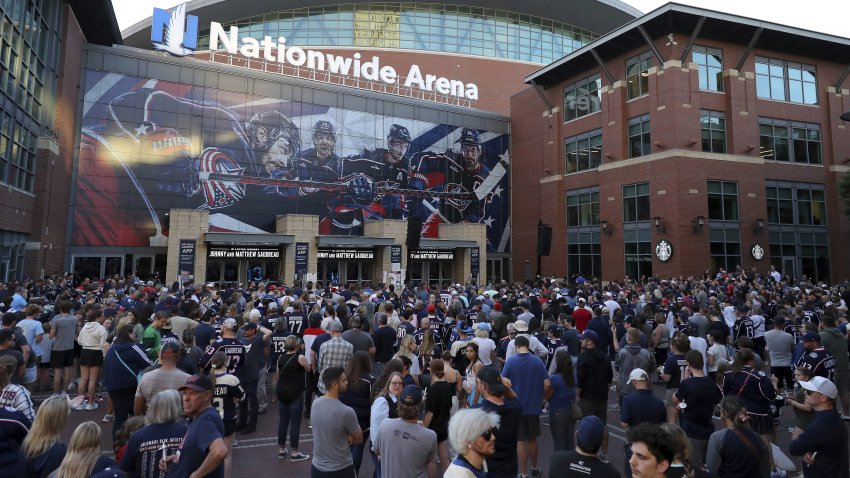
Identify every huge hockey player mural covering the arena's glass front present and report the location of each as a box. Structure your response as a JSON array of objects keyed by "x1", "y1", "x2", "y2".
[{"x1": 73, "y1": 71, "x2": 510, "y2": 252}]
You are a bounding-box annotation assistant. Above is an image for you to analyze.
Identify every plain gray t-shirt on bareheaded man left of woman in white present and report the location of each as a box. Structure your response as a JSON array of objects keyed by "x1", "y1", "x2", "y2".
[{"x1": 310, "y1": 397, "x2": 362, "y2": 470}]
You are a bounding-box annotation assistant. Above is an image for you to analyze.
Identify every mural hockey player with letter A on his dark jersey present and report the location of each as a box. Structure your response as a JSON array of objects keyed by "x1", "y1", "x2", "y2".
[{"x1": 319, "y1": 124, "x2": 411, "y2": 235}]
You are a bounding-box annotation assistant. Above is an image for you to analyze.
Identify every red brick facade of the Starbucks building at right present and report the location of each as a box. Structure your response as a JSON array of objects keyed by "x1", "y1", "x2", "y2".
[{"x1": 511, "y1": 30, "x2": 850, "y2": 280}]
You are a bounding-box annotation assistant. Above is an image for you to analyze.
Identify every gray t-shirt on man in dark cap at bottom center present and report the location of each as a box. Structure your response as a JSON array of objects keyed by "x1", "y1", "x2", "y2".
[{"x1": 375, "y1": 418, "x2": 437, "y2": 478}]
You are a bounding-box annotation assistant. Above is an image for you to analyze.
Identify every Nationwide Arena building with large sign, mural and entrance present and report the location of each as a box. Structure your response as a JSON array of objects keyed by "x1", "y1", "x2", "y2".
[{"x1": 41, "y1": 0, "x2": 640, "y2": 285}]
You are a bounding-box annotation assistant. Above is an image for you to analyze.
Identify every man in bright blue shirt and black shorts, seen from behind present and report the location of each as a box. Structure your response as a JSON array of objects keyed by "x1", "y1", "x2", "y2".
[{"x1": 502, "y1": 335, "x2": 548, "y2": 477}]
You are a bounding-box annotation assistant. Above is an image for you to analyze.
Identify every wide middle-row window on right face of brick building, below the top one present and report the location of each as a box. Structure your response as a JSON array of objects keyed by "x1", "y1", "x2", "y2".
[{"x1": 759, "y1": 118, "x2": 823, "y2": 164}]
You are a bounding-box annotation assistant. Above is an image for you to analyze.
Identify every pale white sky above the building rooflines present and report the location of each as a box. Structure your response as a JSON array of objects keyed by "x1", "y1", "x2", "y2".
[{"x1": 112, "y1": 0, "x2": 850, "y2": 38}]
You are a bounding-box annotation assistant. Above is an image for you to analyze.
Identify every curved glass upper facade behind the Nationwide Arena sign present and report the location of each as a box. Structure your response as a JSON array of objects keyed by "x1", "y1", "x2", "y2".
[{"x1": 198, "y1": 2, "x2": 598, "y2": 64}]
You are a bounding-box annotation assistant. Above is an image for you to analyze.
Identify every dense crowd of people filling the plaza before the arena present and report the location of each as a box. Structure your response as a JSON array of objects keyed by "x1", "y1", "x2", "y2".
[{"x1": 0, "y1": 268, "x2": 850, "y2": 478}]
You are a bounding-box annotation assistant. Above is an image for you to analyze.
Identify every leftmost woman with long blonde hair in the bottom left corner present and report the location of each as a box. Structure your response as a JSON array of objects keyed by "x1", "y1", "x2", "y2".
[{"x1": 21, "y1": 395, "x2": 71, "y2": 478}]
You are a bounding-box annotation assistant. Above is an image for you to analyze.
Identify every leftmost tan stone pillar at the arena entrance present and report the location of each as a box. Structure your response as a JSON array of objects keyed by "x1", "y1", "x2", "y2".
[{"x1": 165, "y1": 209, "x2": 210, "y2": 283}]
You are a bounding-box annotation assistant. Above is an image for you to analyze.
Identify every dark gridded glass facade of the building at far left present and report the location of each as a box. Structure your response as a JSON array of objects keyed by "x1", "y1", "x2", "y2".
[{"x1": 0, "y1": 0, "x2": 63, "y2": 193}]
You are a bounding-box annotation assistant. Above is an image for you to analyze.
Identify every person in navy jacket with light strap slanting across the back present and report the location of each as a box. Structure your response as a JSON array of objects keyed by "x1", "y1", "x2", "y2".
[{"x1": 103, "y1": 324, "x2": 151, "y2": 437}]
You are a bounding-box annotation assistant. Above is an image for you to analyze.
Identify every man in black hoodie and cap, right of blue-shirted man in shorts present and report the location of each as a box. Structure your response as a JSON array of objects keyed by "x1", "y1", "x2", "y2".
[{"x1": 576, "y1": 328, "x2": 614, "y2": 460}]
